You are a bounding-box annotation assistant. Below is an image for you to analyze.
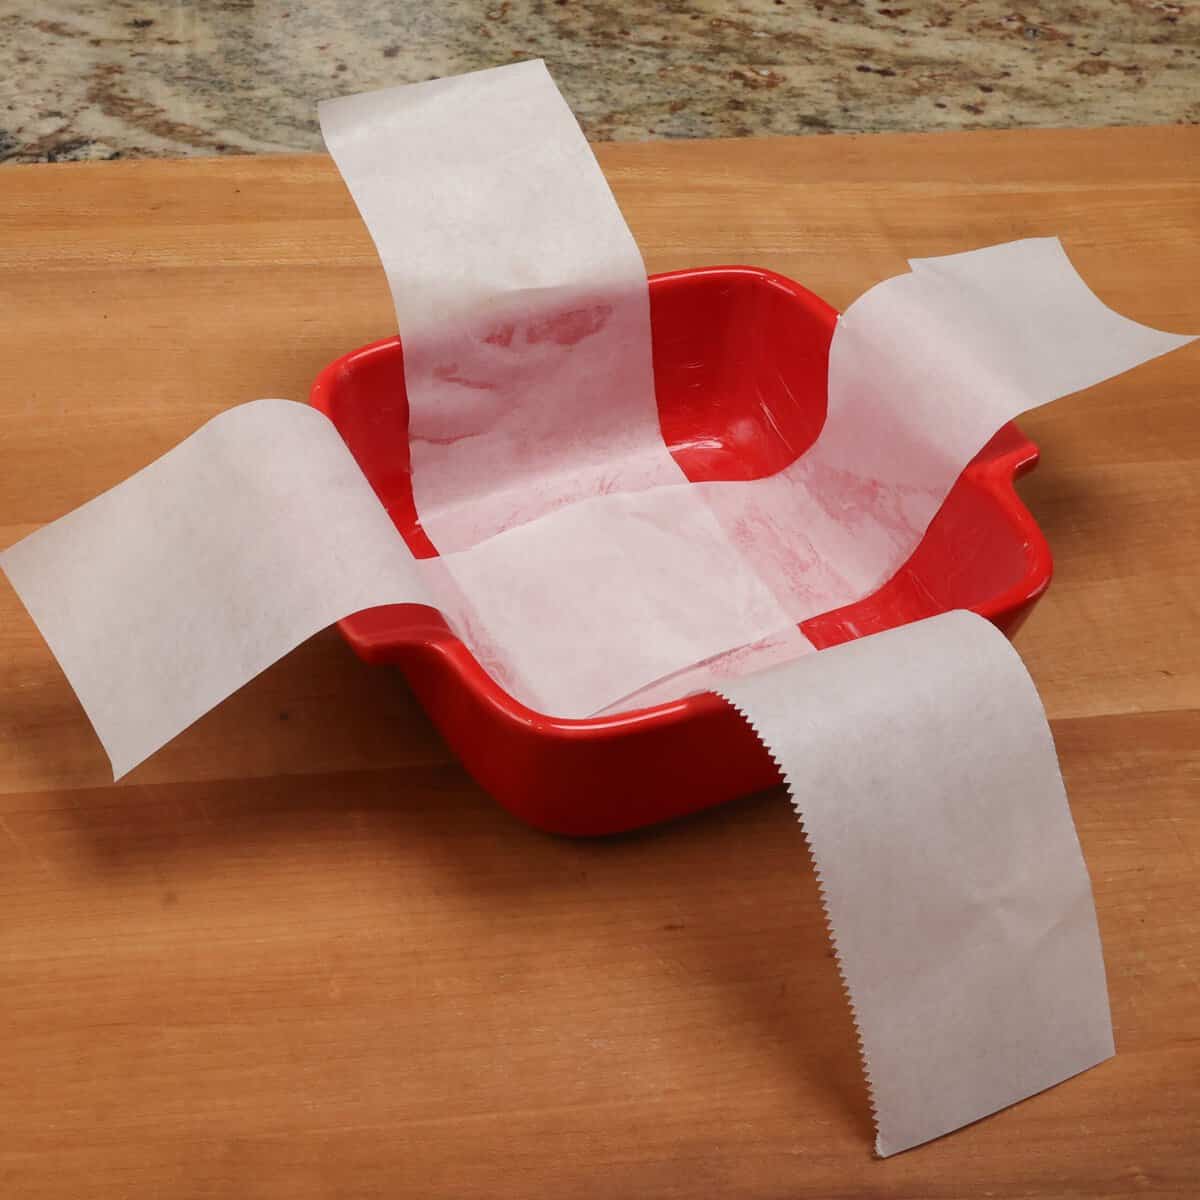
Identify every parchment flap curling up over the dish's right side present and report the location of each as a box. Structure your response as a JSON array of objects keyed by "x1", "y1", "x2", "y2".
[{"x1": 694, "y1": 238, "x2": 1194, "y2": 622}]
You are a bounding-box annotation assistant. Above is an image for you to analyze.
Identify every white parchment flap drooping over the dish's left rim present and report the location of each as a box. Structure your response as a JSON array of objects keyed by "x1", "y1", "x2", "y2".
[{"x1": 0, "y1": 400, "x2": 432, "y2": 778}]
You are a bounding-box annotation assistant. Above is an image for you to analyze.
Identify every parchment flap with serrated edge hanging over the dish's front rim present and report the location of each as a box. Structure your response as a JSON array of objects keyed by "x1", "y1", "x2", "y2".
[{"x1": 720, "y1": 612, "x2": 1114, "y2": 1154}]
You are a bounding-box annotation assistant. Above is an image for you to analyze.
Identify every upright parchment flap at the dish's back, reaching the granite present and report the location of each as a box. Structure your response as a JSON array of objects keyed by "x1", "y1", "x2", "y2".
[{"x1": 320, "y1": 61, "x2": 685, "y2": 553}]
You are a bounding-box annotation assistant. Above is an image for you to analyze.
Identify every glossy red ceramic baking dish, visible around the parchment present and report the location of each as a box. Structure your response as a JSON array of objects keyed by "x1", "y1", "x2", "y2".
[{"x1": 311, "y1": 266, "x2": 1051, "y2": 834}]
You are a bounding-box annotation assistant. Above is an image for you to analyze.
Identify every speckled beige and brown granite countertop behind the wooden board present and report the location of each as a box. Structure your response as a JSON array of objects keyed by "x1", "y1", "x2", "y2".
[{"x1": 0, "y1": 0, "x2": 1200, "y2": 162}]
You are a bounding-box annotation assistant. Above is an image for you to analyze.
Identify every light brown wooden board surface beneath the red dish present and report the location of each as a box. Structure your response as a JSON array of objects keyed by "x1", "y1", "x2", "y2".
[{"x1": 0, "y1": 127, "x2": 1200, "y2": 1200}]
